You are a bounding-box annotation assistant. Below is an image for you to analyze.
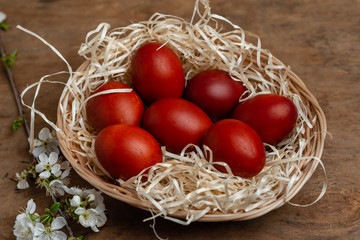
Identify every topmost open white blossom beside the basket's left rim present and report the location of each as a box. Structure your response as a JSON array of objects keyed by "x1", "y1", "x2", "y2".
[{"x1": 29, "y1": 128, "x2": 60, "y2": 157}]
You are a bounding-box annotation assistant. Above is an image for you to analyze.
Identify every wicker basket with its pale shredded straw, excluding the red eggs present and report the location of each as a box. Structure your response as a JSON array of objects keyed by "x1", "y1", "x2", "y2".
[{"x1": 57, "y1": 1, "x2": 326, "y2": 224}]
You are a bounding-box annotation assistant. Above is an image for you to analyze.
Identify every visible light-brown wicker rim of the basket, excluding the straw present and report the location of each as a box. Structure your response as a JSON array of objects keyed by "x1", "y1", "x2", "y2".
[{"x1": 57, "y1": 2, "x2": 327, "y2": 222}]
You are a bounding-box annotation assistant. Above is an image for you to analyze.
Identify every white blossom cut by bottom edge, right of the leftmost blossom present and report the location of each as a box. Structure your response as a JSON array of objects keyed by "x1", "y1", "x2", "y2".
[{"x1": 34, "y1": 217, "x2": 67, "y2": 240}]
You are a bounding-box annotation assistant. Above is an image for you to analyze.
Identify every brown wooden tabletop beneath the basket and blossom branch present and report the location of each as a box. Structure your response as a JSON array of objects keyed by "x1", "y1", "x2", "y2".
[{"x1": 0, "y1": 0, "x2": 360, "y2": 239}]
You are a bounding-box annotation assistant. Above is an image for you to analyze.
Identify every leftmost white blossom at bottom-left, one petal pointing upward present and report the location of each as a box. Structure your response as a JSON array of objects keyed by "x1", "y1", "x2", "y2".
[{"x1": 14, "y1": 199, "x2": 39, "y2": 240}]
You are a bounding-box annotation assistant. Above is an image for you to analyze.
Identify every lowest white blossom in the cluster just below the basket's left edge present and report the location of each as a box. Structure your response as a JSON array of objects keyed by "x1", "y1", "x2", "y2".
[{"x1": 75, "y1": 207, "x2": 107, "y2": 232}]
